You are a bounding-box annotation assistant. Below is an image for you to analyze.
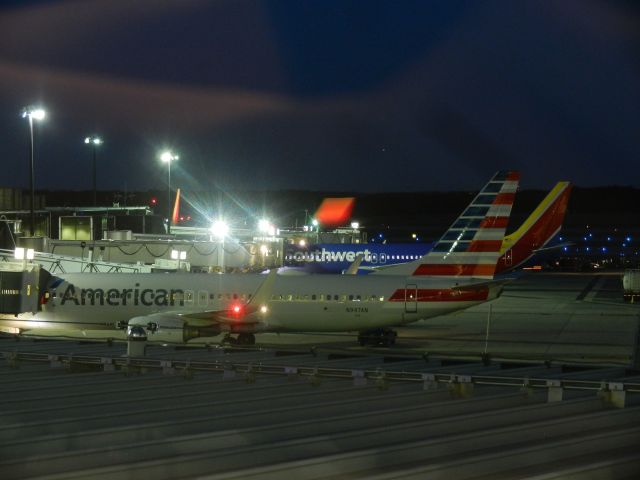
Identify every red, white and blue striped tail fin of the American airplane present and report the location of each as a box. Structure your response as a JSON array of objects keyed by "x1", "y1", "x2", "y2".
[{"x1": 383, "y1": 171, "x2": 520, "y2": 279}]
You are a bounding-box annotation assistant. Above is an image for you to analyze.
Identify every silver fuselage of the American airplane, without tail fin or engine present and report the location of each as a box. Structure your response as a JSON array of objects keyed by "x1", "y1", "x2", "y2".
[{"x1": 0, "y1": 273, "x2": 499, "y2": 332}]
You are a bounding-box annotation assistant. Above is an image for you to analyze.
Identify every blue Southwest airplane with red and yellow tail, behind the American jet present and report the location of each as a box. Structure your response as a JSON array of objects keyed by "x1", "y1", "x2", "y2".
[{"x1": 283, "y1": 182, "x2": 571, "y2": 274}]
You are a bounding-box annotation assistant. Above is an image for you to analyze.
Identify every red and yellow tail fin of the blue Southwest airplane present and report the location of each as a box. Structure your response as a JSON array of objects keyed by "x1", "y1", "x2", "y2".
[{"x1": 498, "y1": 182, "x2": 572, "y2": 271}]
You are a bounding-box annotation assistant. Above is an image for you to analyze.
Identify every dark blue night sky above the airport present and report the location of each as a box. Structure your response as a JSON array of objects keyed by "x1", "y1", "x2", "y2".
[{"x1": 0, "y1": 0, "x2": 640, "y2": 192}]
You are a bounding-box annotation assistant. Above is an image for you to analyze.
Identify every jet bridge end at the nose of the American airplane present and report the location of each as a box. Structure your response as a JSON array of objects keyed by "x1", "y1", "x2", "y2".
[{"x1": 0, "y1": 262, "x2": 51, "y2": 315}]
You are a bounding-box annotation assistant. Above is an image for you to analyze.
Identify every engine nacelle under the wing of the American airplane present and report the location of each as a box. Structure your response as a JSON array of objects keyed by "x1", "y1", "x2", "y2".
[{"x1": 127, "y1": 314, "x2": 220, "y2": 343}]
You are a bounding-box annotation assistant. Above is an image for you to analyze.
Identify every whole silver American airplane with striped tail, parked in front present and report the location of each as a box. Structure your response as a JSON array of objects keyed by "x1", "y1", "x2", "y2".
[{"x1": 0, "y1": 171, "x2": 519, "y2": 345}]
